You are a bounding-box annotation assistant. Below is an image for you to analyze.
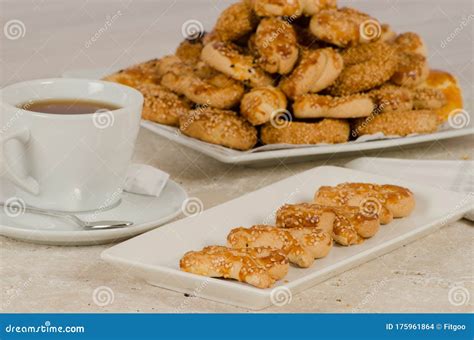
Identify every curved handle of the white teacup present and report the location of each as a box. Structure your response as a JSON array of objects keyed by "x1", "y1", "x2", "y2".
[{"x1": 0, "y1": 128, "x2": 40, "y2": 195}]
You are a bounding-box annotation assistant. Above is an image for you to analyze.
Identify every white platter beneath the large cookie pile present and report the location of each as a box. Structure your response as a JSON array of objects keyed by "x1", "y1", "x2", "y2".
[{"x1": 63, "y1": 69, "x2": 474, "y2": 165}]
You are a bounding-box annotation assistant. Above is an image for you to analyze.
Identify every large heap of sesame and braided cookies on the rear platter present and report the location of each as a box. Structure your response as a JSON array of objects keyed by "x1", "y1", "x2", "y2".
[{"x1": 105, "y1": 0, "x2": 462, "y2": 150}]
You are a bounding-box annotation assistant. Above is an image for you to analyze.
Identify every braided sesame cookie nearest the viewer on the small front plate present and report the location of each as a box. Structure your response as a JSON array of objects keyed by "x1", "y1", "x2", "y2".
[{"x1": 179, "y1": 249, "x2": 275, "y2": 288}]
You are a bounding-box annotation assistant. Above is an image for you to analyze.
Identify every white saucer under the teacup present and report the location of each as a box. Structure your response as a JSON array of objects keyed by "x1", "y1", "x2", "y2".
[{"x1": 0, "y1": 180, "x2": 187, "y2": 245}]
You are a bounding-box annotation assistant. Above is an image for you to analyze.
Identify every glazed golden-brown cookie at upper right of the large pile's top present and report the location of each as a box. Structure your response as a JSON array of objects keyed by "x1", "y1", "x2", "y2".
[{"x1": 309, "y1": 7, "x2": 380, "y2": 47}]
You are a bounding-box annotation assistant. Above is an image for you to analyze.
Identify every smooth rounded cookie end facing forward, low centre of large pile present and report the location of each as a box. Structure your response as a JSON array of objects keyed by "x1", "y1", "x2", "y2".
[{"x1": 240, "y1": 86, "x2": 287, "y2": 125}]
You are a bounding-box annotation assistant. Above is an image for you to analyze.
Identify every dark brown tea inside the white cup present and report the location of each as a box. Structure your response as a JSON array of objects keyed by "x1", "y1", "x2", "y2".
[{"x1": 18, "y1": 99, "x2": 120, "y2": 115}]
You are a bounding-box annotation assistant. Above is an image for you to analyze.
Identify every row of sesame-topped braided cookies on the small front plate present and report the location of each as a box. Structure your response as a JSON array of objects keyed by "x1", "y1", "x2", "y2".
[{"x1": 180, "y1": 183, "x2": 415, "y2": 288}]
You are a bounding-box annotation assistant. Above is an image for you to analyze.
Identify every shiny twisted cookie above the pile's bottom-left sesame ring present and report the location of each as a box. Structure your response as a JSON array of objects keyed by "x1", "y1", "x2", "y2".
[{"x1": 161, "y1": 63, "x2": 244, "y2": 109}]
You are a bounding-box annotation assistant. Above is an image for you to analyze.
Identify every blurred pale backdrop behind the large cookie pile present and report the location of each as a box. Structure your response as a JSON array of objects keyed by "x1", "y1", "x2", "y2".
[{"x1": 0, "y1": 0, "x2": 474, "y2": 102}]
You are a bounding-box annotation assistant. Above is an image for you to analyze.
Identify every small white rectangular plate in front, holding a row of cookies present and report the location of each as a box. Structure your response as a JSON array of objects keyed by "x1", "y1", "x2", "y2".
[{"x1": 102, "y1": 167, "x2": 472, "y2": 309}]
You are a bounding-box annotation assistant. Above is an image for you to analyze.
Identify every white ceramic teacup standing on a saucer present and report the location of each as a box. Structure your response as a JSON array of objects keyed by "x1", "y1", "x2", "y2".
[{"x1": 0, "y1": 79, "x2": 143, "y2": 212}]
